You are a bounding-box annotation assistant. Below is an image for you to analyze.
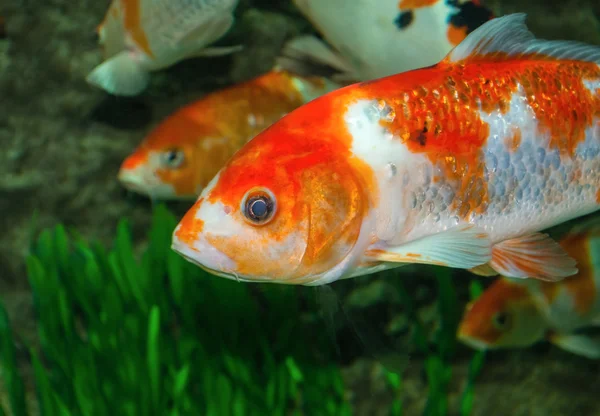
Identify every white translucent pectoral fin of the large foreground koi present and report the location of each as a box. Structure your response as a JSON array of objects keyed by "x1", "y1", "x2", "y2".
[{"x1": 365, "y1": 224, "x2": 492, "y2": 269}]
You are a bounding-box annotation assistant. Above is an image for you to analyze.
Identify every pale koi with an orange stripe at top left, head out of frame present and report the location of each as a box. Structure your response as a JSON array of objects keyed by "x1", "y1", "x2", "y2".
[{"x1": 86, "y1": 0, "x2": 240, "y2": 96}]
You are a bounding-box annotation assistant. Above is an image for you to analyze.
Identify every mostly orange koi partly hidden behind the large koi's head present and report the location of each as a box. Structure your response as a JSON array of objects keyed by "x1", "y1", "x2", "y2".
[{"x1": 118, "y1": 69, "x2": 339, "y2": 199}]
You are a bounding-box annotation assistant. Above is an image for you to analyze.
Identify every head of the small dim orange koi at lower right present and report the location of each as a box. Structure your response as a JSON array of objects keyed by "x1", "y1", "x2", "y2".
[{"x1": 458, "y1": 278, "x2": 547, "y2": 349}]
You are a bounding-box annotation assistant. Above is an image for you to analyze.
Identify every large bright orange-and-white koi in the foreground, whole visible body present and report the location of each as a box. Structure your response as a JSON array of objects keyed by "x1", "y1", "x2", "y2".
[{"x1": 172, "y1": 14, "x2": 600, "y2": 285}]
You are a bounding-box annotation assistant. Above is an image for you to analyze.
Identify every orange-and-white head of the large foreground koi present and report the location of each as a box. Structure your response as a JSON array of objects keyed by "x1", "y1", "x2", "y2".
[{"x1": 172, "y1": 116, "x2": 369, "y2": 285}]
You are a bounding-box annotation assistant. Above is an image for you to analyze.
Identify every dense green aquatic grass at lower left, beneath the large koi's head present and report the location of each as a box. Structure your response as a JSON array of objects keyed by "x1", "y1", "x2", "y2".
[{"x1": 0, "y1": 206, "x2": 350, "y2": 416}]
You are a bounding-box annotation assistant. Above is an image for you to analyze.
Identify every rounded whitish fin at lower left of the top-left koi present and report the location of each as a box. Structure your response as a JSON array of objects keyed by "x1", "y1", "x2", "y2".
[{"x1": 86, "y1": 51, "x2": 150, "y2": 96}]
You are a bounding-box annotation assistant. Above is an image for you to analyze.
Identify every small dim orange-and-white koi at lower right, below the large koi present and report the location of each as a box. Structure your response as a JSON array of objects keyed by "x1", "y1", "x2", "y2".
[{"x1": 458, "y1": 218, "x2": 600, "y2": 358}]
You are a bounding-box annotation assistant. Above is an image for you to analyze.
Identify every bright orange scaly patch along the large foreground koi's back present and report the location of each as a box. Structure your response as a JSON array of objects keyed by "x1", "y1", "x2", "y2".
[{"x1": 362, "y1": 56, "x2": 600, "y2": 223}]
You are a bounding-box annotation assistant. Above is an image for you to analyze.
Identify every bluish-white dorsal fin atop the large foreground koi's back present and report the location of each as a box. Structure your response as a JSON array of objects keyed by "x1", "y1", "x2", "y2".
[{"x1": 444, "y1": 13, "x2": 600, "y2": 64}]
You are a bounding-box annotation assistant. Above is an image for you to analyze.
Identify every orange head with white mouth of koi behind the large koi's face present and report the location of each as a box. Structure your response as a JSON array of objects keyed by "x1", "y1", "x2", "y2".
[{"x1": 118, "y1": 110, "x2": 221, "y2": 200}]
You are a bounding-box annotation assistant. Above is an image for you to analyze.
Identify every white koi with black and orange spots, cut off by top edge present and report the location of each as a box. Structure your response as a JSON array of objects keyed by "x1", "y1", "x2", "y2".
[{"x1": 279, "y1": 0, "x2": 493, "y2": 81}]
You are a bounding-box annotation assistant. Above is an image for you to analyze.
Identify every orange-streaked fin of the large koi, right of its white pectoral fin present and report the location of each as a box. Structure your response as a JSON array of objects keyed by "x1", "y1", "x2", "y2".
[{"x1": 490, "y1": 233, "x2": 577, "y2": 282}]
